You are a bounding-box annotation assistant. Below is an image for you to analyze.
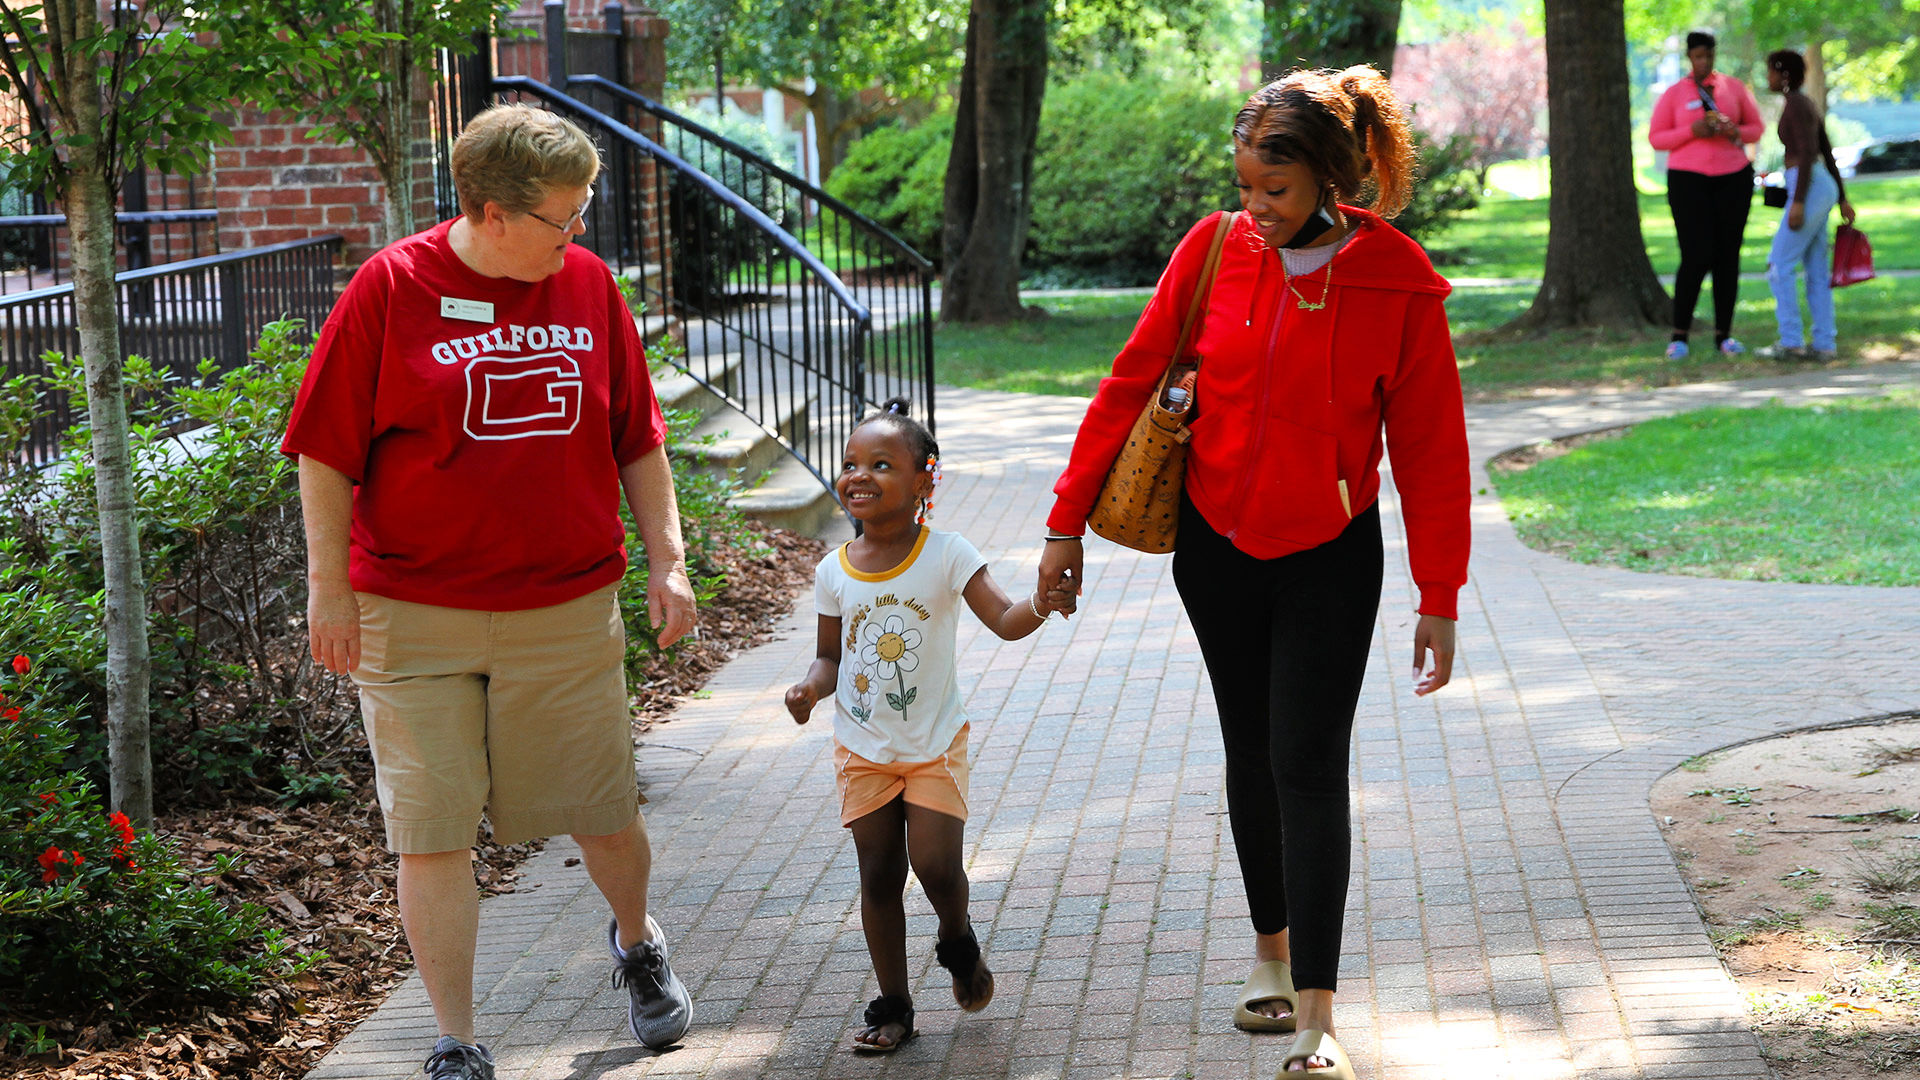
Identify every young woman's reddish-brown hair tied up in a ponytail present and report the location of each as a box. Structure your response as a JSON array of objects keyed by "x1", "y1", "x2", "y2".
[{"x1": 1233, "y1": 63, "x2": 1415, "y2": 217}]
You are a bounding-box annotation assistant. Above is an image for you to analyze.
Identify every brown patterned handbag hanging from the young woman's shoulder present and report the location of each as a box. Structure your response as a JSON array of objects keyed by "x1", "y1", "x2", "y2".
[{"x1": 1087, "y1": 213, "x2": 1235, "y2": 555}]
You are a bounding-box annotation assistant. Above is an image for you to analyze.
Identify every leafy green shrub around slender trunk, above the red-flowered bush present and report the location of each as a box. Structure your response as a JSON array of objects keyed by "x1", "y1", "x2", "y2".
[{"x1": 0, "y1": 321, "x2": 355, "y2": 807}]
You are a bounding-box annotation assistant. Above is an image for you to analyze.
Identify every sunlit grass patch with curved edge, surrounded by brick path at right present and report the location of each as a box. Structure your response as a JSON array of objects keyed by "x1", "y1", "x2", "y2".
[{"x1": 1494, "y1": 392, "x2": 1920, "y2": 586}]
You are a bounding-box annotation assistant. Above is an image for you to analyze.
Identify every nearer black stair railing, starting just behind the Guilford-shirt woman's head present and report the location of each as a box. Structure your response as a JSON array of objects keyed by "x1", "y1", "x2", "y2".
[{"x1": 493, "y1": 77, "x2": 929, "y2": 488}]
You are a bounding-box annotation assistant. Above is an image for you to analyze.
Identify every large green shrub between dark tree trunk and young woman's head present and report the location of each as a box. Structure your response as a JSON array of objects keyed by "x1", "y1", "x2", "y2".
[{"x1": 1025, "y1": 73, "x2": 1240, "y2": 284}]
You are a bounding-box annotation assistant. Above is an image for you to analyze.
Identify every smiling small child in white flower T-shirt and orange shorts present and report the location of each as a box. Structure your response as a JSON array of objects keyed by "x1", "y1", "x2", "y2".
[{"x1": 787, "y1": 398, "x2": 1073, "y2": 1051}]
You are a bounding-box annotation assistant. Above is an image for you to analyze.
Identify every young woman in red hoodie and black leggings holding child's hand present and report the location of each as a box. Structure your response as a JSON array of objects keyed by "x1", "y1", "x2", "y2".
[{"x1": 1041, "y1": 67, "x2": 1471, "y2": 1076}]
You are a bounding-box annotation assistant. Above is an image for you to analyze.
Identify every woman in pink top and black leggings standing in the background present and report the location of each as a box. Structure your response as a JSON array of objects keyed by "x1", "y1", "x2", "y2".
[{"x1": 1647, "y1": 31, "x2": 1764, "y2": 359}]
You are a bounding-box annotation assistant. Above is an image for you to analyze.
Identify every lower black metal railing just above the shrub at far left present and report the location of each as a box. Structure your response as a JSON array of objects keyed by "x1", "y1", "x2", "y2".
[{"x1": 0, "y1": 233, "x2": 346, "y2": 465}]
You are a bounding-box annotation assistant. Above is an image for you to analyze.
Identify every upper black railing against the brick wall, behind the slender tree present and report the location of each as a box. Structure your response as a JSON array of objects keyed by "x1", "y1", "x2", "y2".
[{"x1": 0, "y1": 209, "x2": 221, "y2": 296}]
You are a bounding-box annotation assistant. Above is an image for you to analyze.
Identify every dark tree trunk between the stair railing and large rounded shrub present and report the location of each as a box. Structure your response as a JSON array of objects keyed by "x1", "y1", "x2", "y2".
[{"x1": 941, "y1": 0, "x2": 1048, "y2": 323}]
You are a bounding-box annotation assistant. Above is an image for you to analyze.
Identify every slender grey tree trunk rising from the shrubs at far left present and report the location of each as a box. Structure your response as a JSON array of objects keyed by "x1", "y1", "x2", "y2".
[{"x1": 65, "y1": 16, "x2": 153, "y2": 828}]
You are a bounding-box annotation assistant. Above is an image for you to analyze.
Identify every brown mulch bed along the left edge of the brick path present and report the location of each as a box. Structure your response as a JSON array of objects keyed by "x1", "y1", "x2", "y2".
[{"x1": 0, "y1": 528, "x2": 824, "y2": 1080}]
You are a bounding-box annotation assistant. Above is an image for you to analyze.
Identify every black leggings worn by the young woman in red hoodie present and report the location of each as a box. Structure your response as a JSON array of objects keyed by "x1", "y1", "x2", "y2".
[{"x1": 1173, "y1": 498, "x2": 1382, "y2": 990}]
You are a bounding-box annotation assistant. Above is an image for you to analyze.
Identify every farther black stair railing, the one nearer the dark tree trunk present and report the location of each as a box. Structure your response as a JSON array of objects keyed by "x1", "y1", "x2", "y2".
[{"x1": 566, "y1": 75, "x2": 935, "y2": 427}]
